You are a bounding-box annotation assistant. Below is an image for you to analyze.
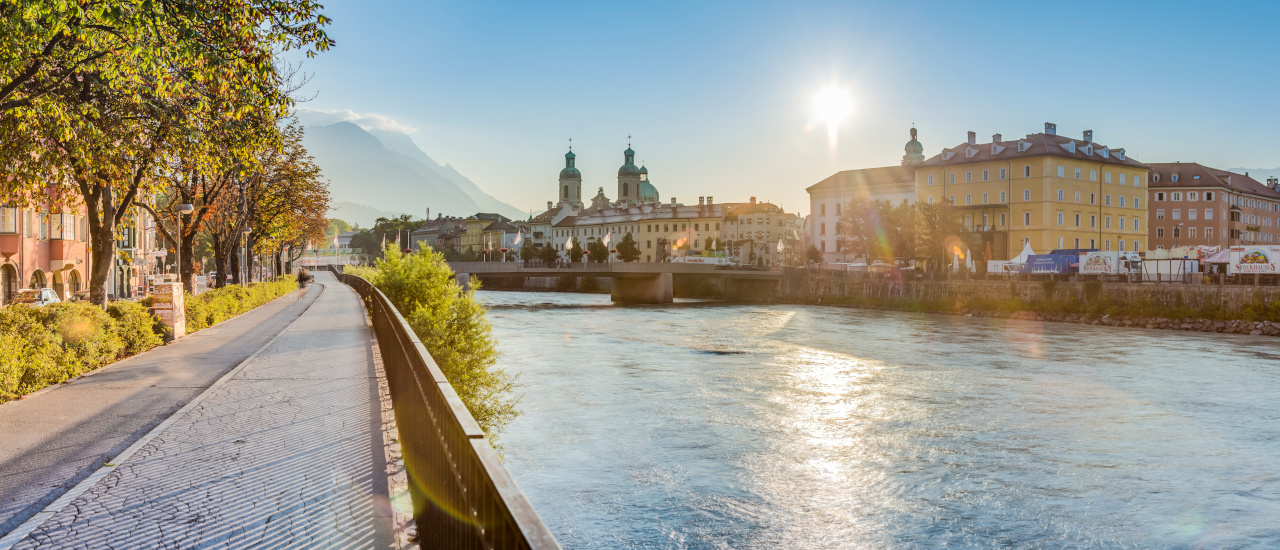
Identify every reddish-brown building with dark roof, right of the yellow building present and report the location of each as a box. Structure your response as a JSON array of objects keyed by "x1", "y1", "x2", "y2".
[{"x1": 1147, "y1": 162, "x2": 1280, "y2": 249}]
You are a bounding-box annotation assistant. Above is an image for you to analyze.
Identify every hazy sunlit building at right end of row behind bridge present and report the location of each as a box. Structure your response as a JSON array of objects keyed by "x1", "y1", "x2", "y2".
[{"x1": 722, "y1": 197, "x2": 804, "y2": 265}]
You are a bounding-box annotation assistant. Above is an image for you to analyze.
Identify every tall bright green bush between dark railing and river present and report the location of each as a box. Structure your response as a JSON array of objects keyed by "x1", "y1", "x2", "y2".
[{"x1": 371, "y1": 248, "x2": 518, "y2": 437}]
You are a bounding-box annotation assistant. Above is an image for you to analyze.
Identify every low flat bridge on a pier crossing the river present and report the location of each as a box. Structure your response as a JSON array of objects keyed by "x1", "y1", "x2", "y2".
[{"x1": 449, "y1": 262, "x2": 782, "y2": 303}]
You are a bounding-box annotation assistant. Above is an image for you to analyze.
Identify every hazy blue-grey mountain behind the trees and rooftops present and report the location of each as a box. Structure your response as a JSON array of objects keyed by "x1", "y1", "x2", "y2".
[{"x1": 296, "y1": 122, "x2": 522, "y2": 228}]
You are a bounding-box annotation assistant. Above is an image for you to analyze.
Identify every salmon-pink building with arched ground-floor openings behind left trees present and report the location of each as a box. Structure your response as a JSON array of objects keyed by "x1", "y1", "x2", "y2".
[{"x1": 0, "y1": 196, "x2": 90, "y2": 304}]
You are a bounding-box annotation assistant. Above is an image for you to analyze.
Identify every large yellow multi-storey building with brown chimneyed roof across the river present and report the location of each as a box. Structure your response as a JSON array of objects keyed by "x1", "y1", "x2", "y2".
[{"x1": 915, "y1": 123, "x2": 1148, "y2": 260}]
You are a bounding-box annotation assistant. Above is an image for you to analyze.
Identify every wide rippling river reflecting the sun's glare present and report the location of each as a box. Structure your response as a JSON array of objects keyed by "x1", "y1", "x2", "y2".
[{"x1": 480, "y1": 292, "x2": 1280, "y2": 549}]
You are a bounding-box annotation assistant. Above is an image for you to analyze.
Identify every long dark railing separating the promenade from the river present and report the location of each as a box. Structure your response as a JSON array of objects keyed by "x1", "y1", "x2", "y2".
[{"x1": 329, "y1": 266, "x2": 561, "y2": 550}]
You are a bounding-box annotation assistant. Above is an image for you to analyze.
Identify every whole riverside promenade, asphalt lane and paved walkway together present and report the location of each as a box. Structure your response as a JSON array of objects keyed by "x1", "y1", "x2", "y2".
[{"x1": 0, "y1": 272, "x2": 393, "y2": 550}]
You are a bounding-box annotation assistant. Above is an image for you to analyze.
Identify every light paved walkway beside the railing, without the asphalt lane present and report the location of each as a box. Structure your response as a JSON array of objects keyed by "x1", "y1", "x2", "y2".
[{"x1": 7, "y1": 274, "x2": 392, "y2": 549}]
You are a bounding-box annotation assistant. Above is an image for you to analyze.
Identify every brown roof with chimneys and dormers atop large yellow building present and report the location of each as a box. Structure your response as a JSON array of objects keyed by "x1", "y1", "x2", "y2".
[{"x1": 919, "y1": 132, "x2": 1149, "y2": 169}]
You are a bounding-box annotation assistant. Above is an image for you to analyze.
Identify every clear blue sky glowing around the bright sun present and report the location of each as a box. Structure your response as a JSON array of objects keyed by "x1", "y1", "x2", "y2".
[{"x1": 291, "y1": 0, "x2": 1280, "y2": 215}]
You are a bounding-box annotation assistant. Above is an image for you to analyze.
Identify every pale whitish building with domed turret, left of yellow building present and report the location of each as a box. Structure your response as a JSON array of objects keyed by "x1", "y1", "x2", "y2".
[{"x1": 805, "y1": 128, "x2": 924, "y2": 263}]
